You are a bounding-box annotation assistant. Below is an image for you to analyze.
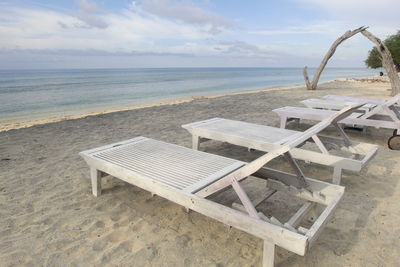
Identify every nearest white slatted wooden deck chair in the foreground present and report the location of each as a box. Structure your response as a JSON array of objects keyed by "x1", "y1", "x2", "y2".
[{"x1": 80, "y1": 108, "x2": 350, "y2": 266}]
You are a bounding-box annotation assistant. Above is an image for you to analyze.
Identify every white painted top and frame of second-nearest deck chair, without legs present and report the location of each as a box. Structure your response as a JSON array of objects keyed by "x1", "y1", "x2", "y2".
[{"x1": 182, "y1": 110, "x2": 378, "y2": 182}]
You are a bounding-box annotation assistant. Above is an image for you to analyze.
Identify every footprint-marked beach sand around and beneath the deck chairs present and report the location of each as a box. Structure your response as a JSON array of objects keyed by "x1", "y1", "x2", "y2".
[{"x1": 0, "y1": 79, "x2": 400, "y2": 266}]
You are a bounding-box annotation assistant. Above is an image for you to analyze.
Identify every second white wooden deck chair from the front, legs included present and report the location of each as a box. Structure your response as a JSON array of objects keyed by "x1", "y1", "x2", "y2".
[{"x1": 182, "y1": 108, "x2": 378, "y2": 184}]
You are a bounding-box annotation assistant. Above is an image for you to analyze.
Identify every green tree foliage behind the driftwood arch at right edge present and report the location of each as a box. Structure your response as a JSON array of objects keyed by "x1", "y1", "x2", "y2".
[{"x1": 365, "y1": 31, "x2": 400, "y2": 69}]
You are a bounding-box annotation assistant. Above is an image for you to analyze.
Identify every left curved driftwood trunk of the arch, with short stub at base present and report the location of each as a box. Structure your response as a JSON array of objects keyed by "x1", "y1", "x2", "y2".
[{"x1": 303, "y1": 26, "x2": 368, "y2": 90}]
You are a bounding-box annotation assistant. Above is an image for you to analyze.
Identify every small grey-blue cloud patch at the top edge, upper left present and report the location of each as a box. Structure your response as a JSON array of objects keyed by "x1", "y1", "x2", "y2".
[{"x1": 77, "y1": 0, "x2": 108, "y2": 29}]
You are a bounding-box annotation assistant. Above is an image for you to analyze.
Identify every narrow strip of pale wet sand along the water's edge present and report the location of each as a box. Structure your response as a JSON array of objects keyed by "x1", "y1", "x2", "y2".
[{"x1": 0, "y1": 83, "x2": 304, "y2": 132}]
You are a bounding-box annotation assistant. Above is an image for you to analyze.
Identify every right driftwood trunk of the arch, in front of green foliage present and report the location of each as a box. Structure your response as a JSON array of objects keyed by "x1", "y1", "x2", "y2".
[{"x1": 361, "y1": 30, "x2": 400, "y2": 96}]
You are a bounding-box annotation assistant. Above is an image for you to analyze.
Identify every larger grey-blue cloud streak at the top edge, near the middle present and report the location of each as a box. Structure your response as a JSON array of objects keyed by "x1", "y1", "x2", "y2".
[{"x1": 133, "y1": 0, "x2": 233, "y2": 34}]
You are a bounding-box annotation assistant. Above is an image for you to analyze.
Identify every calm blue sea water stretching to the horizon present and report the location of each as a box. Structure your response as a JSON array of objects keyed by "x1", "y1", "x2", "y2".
[{"x1": 0, "y1": 68, "x2": 377, "y2": 123}]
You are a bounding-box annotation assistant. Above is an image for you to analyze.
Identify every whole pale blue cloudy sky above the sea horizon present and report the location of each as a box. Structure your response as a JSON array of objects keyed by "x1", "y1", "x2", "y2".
[{"x1": 0, "y1": 0, "x2": 400, "y2": 69}]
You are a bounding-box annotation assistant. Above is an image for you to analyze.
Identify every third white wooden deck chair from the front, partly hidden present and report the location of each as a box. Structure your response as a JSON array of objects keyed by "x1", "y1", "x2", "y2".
[{"x1": 273, "y1": 102, "x2": 400, "y2": 150}]
